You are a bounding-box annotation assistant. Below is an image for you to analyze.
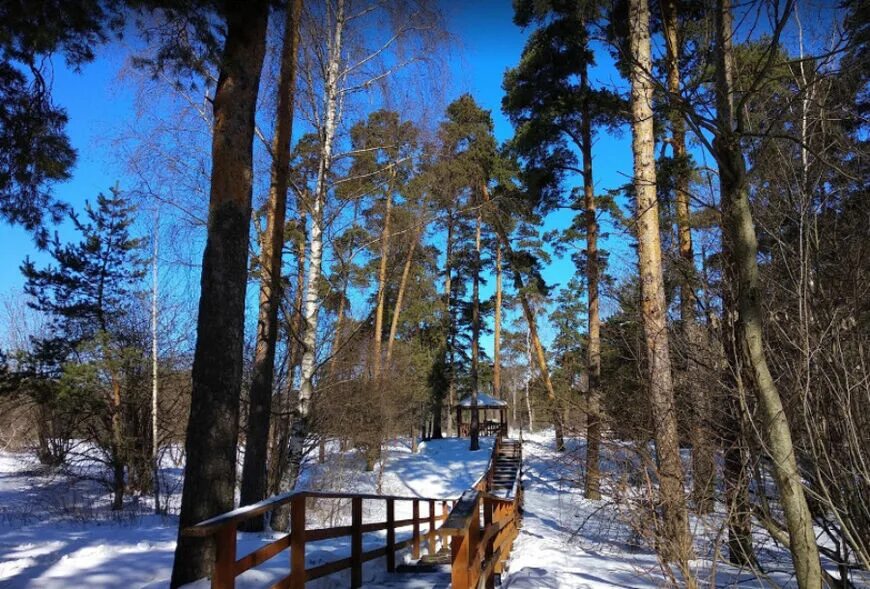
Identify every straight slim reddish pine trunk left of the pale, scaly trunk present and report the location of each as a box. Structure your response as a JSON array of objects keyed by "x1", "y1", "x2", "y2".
[{"x1": 580, "y1": 55, "x2": 601, "y2": 500}]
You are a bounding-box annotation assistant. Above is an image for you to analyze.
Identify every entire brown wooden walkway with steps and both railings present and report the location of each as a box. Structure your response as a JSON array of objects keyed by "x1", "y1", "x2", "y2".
[{"x1": 182, "y1": 437, "x2": 523, "y2": 589}]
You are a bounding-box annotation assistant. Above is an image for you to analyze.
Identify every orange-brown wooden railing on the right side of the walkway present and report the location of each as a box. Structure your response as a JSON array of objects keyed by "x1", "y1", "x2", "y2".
[{"x1": 441, "y1": 437, "x2": 523, "y2": 589}]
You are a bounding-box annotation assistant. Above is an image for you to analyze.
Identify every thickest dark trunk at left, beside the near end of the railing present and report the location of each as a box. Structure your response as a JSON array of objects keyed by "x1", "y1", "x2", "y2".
[{"x1": 171, "y1": 2, "x2": 268, "y2": 587}]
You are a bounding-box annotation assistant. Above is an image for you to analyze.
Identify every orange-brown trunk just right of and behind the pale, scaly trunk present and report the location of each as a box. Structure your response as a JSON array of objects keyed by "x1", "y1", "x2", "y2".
[{"x1": 661, "y1": 0, "x2": 716, "y2": 514}]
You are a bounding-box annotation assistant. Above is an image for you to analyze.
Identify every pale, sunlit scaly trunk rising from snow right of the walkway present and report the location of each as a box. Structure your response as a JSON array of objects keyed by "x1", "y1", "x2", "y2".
[{"x1": 629, "y1": 0, "x2": 692, "y2": 564}]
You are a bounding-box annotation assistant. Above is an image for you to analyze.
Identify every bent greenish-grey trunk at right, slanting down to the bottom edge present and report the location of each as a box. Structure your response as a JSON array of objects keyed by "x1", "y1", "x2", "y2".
[{"x1": 714, "y1": 0, "x2": 822, "y2": 589}]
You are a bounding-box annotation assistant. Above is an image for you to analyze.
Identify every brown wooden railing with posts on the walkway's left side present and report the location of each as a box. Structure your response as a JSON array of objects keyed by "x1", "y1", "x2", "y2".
[{"x1": 182, "y1": 491, "x2": 456, "y2": 589}]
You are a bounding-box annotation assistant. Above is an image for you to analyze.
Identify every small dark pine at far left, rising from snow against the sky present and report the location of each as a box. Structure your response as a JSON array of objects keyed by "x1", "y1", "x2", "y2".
[{"x1": 22, "y1": 188, "x2": 145, "y2": 510}]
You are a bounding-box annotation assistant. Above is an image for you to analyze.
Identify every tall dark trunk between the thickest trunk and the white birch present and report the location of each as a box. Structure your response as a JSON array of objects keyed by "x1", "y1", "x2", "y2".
[{"x1": 239, "y1": 0, "x2": 302, "y2": 532}]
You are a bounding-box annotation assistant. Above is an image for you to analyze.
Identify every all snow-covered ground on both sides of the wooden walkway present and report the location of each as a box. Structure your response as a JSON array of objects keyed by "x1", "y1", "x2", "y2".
[{"x1": 0, "y1": 431, "x2": 870, "y2": 589}]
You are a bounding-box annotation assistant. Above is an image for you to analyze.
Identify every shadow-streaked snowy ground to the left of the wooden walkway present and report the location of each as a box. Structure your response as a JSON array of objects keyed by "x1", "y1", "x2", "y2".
[{"x1": 0, "y1": 439, "x2": 492, "y2": 589}]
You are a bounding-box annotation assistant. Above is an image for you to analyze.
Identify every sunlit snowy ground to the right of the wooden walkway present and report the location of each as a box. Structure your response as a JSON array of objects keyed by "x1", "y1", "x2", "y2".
[{"x1": 502, "y1": 431, "x2": 870, "y2": 589}]
